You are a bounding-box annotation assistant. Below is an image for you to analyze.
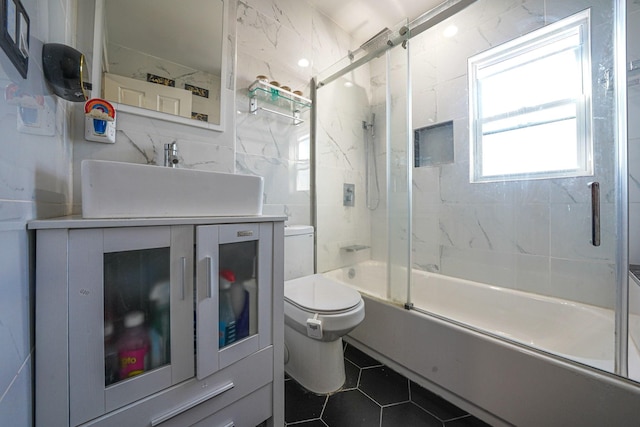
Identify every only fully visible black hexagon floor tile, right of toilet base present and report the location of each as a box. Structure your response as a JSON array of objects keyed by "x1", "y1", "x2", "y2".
[{"x1": 358, "y1": 366, "x2": 409, "y2": 406}]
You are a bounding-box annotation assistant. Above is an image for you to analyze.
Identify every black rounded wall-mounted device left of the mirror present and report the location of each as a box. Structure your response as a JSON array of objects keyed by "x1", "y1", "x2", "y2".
[{"x1": 42, "y1": 43, "x2": 88, "y2": 102}]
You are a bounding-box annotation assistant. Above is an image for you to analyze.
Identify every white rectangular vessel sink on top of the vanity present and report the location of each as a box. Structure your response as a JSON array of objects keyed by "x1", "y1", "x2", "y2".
[{"x1": 81, "y1": 160, "x2": 264, "y2": 218}]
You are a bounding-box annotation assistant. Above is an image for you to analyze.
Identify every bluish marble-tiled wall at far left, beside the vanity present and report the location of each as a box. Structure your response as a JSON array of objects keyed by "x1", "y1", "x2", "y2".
[{"x1": 0, "y1": 0, "x2": 72, "y2": 426}]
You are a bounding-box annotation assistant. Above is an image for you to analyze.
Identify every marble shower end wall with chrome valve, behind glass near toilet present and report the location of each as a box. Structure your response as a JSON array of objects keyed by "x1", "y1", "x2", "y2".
[{"x1": 316, "y1": 69, "x2": 376, "y2": 272}]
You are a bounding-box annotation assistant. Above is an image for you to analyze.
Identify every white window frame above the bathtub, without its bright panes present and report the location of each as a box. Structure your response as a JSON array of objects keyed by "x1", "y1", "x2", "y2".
[{"x1": 468, "y1": 9, "x2": 593, "y2": 182}]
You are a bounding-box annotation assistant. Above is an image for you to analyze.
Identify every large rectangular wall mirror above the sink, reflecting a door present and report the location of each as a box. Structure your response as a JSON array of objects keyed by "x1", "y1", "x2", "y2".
[{"x1": 92, "y1": 0, "x2": 226, "y2": 130}]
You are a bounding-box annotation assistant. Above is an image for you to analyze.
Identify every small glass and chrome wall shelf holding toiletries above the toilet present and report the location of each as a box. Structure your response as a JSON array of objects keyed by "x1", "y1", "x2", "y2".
[{"x1": 249, "y1": 80, "x2": 313, "y2": 126}]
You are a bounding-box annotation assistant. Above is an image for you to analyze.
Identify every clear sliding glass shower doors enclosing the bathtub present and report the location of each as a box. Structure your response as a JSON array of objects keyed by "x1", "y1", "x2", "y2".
[{"x1": 315, "y1": 0, "x2": 640, "y2": 380}]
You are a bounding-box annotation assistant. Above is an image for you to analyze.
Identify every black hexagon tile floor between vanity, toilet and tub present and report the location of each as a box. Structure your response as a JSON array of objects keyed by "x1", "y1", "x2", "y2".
[{"x1": 285, "y1": 344, "x2": 488, "y2": 427}]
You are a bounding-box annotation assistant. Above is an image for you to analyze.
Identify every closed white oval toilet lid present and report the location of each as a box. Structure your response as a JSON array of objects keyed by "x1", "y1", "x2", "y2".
[{"x1": 284, "y1": 274, "x2": 362, "y2": 313}]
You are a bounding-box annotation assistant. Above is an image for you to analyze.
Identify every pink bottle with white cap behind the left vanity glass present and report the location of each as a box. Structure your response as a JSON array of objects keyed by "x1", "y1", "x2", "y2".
[{"x1": 118, "y1": 311, "x2": 149, "y2": 380}]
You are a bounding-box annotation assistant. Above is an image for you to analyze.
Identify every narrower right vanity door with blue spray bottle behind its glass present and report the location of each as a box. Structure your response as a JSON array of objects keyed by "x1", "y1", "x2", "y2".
[{"x1": 196, "y1": 224, "x2": 273, "y2": 379}]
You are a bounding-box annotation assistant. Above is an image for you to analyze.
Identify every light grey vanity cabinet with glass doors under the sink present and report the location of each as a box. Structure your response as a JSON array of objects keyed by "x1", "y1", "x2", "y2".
[{"x1": 29, "y1": 216, "x2": 284, "y2": 427}]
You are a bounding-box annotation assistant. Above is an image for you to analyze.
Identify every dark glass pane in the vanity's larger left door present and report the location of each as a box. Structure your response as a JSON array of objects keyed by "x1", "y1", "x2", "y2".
[{"x1": 104, "y1": 247, "x2": 171, "y2": 386}]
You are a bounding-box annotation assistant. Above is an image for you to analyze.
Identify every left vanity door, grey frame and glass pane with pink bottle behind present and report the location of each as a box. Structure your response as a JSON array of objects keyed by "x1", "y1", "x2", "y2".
[{"x1": 69, "y1": 226, "x2": 194, "y2": 425}]
